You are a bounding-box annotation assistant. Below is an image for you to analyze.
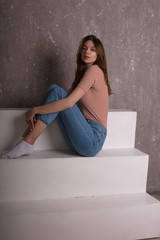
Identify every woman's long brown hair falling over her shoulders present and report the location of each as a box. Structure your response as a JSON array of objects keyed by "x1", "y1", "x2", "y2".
[{"x1": 72, "y1": 35, "x2": 112, "y2": 95}]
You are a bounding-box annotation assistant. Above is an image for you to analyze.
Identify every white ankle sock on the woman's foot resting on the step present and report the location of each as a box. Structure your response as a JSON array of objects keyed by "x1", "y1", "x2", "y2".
[{"x1": 2, "y1": 140, "x2": 34, "y2": 158}]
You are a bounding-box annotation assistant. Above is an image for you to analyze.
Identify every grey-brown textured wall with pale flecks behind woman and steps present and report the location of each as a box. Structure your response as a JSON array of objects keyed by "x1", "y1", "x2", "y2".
[{"x1": 0, "y1": 0, "x2": 160, "y2": 192}]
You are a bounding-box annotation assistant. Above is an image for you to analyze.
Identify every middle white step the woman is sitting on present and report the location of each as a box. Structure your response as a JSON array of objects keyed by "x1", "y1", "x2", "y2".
[{"x1": 0, "y1": 148, "x2": 148, "y2": 201}]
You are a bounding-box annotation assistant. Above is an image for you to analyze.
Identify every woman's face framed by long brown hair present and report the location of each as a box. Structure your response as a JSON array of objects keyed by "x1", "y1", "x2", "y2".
[{"x1": 81, "y1": 40, "x2": 97, "y2": 66}]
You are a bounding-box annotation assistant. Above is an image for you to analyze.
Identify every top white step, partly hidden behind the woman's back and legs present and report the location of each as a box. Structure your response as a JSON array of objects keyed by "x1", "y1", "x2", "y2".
[{"x1": 0, "y1": 109, "x2": 136, "y2": 152}]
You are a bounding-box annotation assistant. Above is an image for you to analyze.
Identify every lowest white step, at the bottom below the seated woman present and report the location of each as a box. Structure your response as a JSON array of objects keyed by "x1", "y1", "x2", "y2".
[{"x1": 0, "y1": 193, "x2": 160, "y2": 240}]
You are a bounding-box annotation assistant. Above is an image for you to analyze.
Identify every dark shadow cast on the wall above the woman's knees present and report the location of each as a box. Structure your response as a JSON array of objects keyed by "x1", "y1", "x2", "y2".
[{"x1": 29, "y1": 43, "x2": 64, "y2": 105}]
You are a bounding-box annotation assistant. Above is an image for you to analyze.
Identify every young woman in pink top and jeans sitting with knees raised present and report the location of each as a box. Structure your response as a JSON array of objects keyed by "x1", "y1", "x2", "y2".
[{"x1": 2, "y1": 35, "x2": 111, "y2": 158}]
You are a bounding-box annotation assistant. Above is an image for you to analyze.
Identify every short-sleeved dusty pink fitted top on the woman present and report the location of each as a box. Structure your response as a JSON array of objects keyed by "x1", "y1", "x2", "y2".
[{"x1": 77, "y1": 65, "x2": 108, "y2": 128}]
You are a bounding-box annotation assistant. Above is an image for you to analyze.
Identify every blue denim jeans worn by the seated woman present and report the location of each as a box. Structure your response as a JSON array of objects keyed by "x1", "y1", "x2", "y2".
[{"x1": 37, "y1": 84, "x2": 107, "y2": 157}]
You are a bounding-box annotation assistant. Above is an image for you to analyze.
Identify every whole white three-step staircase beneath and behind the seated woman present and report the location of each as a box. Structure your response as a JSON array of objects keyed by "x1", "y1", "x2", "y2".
[{"x1": 0, "y1": 109, "x2": 160, "y2": 240}]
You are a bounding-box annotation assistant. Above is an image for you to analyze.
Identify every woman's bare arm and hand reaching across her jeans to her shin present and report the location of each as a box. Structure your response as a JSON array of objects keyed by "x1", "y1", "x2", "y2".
[{"x1": 25, "y1": 87, "x2": 85, "y2": 130}]
